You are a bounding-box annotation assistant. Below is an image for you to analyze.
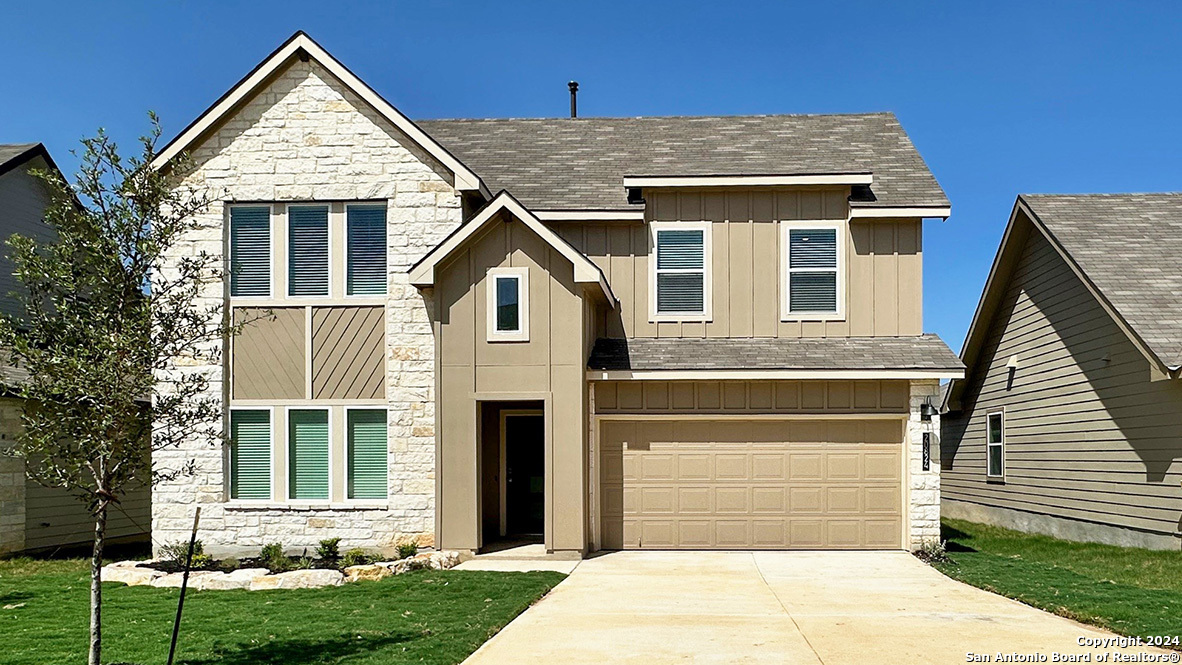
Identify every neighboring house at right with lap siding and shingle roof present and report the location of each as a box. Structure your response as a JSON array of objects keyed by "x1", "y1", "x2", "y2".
[{"x1": 941, "y1": 194, "x2": 1182, "y2": 549}]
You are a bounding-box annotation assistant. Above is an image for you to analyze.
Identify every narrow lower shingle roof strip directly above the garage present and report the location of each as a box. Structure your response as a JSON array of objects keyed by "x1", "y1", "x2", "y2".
[{"x1": 587, "y1": 334, "x2": 965, "y2": 371}]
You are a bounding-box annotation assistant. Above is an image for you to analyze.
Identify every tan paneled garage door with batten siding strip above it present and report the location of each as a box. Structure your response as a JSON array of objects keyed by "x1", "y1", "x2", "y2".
[{"x1": 595, "y1": 380, "x2": 910, "y2": 549}]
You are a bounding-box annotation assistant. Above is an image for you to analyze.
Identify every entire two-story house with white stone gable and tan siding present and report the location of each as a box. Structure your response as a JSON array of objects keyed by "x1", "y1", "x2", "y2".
[{"x1": 152, "y1": 33, "x2": 963, "y2": 555}]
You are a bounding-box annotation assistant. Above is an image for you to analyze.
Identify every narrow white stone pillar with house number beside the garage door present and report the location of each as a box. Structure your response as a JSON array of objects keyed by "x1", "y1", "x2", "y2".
[{"x1": 907, "y1": 379, "x2": 940, "y2": 549}]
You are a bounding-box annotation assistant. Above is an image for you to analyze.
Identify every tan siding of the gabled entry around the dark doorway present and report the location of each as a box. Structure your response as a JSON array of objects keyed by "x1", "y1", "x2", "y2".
[{"x1": 435, "y1": 213, "x2": 589, "y2": 552}]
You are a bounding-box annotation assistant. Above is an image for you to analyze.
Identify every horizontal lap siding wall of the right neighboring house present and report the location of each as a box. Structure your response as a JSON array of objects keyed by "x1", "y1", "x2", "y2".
[{"x1": 941, "y1": 223, "x2": 1182, "y2": 548}]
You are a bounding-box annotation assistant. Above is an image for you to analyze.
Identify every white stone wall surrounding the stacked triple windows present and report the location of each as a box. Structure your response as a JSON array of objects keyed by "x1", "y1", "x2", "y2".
[{"x1": 159, "y1": 60, "x2": 461, "y2": 553}]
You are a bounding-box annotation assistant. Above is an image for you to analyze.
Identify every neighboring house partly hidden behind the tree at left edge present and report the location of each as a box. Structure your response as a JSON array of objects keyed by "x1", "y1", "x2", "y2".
[{"x1": 0, "y1": 143, "x2": 151, "y2": 555}]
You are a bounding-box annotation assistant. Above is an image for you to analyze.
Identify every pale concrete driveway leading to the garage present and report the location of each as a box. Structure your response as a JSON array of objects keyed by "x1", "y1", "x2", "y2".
[{"x1": 466, "y1": 552, "x2": 1176, "y2": 665}]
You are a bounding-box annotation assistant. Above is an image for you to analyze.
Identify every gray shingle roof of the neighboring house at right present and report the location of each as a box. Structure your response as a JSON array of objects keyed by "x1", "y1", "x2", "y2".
[{"x1": 1021, "y1": 193, "x2": 1182, "y2": 367}]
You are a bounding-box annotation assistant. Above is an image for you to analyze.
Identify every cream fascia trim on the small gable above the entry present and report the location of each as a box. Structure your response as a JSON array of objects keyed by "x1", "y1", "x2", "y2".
[{"x1": 408, "y1": 191, "x2": 617, "y2": 307}]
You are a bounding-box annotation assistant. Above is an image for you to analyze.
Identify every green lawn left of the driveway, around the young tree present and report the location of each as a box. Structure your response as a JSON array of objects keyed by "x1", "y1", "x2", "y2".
[{"x1": 0, "y1": 559, "x2": 563, "y2": 665}]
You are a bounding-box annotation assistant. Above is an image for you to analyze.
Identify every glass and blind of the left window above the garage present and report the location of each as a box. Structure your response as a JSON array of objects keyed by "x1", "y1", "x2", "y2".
[{"x1": 656, "y1": 230, "x2": 706, "y2": 313}]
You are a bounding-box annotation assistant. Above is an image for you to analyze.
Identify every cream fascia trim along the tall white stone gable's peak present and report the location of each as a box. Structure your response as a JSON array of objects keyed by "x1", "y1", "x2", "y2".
[{"x1": 150, "y1": 33, "x2": 491, "y2": 198}]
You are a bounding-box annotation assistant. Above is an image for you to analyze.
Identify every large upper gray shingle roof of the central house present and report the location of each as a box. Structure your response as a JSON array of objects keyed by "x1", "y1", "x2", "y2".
[{"x1": 417, "y1": 113, "x2": 948, "y2": 210}]
